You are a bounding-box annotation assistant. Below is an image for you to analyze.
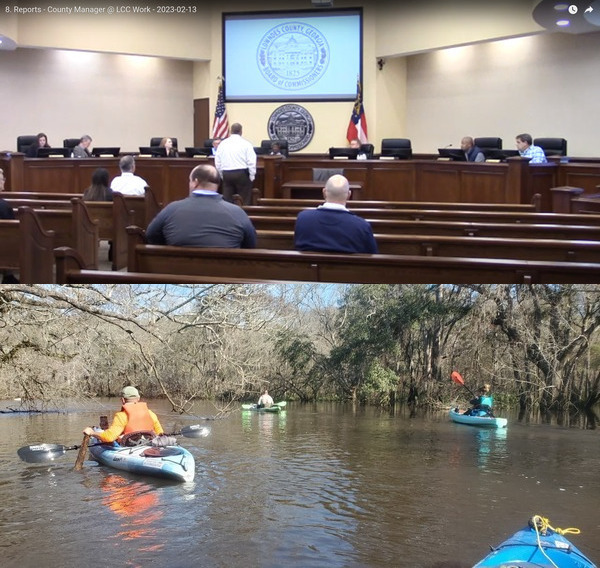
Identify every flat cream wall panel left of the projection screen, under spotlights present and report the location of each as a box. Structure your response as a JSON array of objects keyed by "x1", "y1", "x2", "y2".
[{"x1": 0, "y1": 49, "x2": 194, "y2": 151}]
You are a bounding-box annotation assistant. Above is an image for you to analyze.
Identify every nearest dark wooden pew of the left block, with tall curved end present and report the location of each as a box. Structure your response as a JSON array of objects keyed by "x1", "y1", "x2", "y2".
[{"x1": 0, "y1": 207, "x2": 55, "y2": 284}]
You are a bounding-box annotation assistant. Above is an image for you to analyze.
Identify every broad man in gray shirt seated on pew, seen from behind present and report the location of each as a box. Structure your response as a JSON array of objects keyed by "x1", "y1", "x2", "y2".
[{"x1": 146, "y1": 164, "x2": 256, "y2": 248}]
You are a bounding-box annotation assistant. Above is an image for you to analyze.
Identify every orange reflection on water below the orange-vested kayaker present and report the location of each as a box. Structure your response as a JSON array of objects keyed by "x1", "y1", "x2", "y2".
[{"x1": 100, "y1": 473, "x2": 164, "y2": 552}]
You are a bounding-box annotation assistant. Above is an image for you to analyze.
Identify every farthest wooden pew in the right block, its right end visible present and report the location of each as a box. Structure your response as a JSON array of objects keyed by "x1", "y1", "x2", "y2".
[{"x1": 252, "y1": 193, "x2": 541, "y2": 213}]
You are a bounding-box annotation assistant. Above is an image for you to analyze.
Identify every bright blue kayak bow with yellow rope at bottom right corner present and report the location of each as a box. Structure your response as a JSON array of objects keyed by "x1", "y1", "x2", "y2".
[{"x1": 473, "y1": 517, "x2": 596, "y2": 568}]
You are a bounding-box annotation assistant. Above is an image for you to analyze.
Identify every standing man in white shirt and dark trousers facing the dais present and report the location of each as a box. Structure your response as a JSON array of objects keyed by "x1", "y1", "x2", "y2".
[{"x1": 215, "y1": 122, "x2": 256, "y2": 205}]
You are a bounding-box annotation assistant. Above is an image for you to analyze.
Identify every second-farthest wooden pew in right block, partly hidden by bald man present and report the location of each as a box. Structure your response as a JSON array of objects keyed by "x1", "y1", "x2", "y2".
[{"x1": 250, "y1": 215, "x2": 600, "y2": 241}]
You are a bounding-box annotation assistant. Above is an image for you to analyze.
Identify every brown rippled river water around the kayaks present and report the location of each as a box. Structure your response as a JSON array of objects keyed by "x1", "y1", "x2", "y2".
[{"x1": 0, "y1": 401, "x2": 600, "y2": 568}]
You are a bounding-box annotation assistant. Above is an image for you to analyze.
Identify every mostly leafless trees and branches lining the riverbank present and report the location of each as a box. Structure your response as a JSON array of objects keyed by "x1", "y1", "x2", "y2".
[{"x1": 0, "y1": 284, "x2": 600, "y2": 418}]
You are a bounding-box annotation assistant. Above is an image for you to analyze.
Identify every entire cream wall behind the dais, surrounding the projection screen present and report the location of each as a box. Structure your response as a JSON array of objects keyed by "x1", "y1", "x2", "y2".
[{"x1": 0, "y1": 0, "x2": 600, "y2": 156}]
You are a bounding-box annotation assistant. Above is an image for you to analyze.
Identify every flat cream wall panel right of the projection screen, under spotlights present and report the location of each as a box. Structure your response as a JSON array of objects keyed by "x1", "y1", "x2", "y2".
[{"x1": 406, "y1": 33, "x2": 600, "y2": 156}]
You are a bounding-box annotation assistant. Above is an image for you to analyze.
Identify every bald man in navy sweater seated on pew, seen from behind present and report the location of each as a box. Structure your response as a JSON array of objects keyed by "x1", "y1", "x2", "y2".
[{"x1": 294, "y1": 174, "x2": 377, "y2": 254}]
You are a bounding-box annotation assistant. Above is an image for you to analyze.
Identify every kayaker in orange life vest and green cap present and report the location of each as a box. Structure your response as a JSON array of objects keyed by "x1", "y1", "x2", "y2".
[{"x1": 83, "y1": 386, "x2": 164, "y2": 442}]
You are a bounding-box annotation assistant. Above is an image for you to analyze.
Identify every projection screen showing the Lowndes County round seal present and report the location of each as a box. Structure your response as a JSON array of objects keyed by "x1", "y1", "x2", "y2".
[{"x1": 223, "y1": 9, "x2": 362, "y2": 101}]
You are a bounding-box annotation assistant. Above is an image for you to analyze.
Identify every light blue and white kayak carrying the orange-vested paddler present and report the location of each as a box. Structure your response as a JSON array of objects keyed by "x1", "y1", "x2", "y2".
[{"x1": 89, "y1": 442, "x2": 196, "y2": 481}]
